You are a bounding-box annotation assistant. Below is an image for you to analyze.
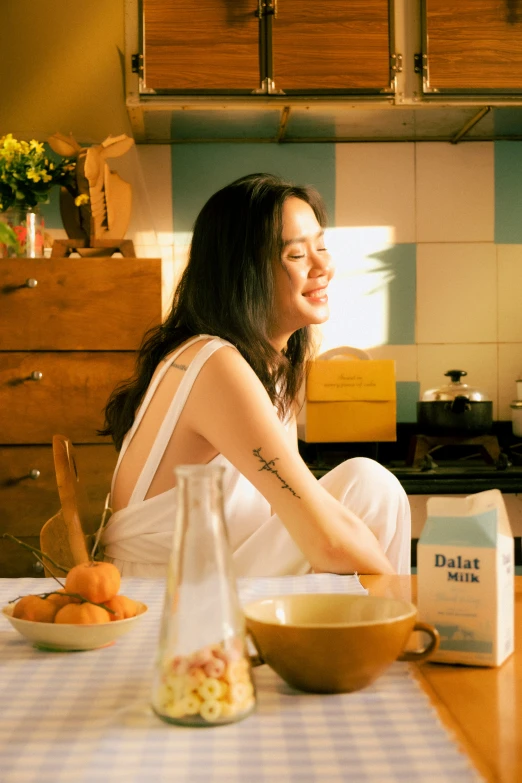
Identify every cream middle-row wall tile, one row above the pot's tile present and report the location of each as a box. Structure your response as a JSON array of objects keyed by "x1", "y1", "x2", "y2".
[{"x1": 417, "y1": 242, "x2": 497, "y2": 343}]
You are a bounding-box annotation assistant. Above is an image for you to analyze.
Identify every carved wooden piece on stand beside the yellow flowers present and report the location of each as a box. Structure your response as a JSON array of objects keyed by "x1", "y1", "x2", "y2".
[{"x1": 48, "y1": 133, "x2": 134, "y2": 256}]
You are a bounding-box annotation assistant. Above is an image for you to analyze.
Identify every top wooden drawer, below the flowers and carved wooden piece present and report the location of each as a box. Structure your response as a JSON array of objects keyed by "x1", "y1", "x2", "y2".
[{"x1": 0, "y1": 258, "x2": 161, "y2": 351}]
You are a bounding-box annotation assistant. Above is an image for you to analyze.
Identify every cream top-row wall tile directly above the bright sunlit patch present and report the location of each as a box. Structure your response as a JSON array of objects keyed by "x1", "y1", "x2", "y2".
[{"x1": 335, "y1": 142, "x2": 415, "y2": 243}]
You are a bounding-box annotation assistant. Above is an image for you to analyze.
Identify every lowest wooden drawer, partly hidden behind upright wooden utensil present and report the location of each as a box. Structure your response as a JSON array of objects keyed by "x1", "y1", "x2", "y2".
[{"x1": 0, "y1": 445, "x2": 117, "y2": 577}]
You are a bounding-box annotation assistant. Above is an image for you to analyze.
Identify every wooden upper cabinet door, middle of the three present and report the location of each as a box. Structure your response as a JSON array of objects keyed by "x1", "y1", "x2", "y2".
[{"x1": 272, "y1": 0, "x2": 391, "y2": 92}]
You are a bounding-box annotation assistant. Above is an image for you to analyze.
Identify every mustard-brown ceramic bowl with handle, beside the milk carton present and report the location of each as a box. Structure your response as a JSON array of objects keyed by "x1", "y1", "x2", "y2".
[{"x1": 244, "y1": 594, "x2": 439, "y2": 693}]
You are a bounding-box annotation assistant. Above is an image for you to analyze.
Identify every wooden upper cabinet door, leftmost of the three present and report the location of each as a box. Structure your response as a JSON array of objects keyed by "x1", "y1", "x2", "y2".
[{"x1": 142, "y1": 0, "x2": 260, "y2": 93}]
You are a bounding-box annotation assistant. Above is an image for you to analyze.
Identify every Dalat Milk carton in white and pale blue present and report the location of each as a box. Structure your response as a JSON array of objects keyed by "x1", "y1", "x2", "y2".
[{"x1": 417, "y1": 489, "x2": 515, "y2": 666}]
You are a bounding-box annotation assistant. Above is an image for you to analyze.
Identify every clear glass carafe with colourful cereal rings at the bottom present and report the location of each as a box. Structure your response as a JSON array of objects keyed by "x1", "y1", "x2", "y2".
[{"x1": 152, "y1": 465, "x2": 255, "y2": 726}]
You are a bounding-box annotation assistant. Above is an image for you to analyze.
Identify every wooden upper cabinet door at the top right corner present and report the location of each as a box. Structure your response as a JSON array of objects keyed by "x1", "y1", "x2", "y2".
[{"x1": 422, "y1": 0, "x2": 522, "y2": 93}]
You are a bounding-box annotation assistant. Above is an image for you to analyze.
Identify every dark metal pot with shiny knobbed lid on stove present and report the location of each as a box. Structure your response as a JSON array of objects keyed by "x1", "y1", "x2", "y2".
[{"x1": 417, "y1": 370, "x2": 493, "y2": 436}]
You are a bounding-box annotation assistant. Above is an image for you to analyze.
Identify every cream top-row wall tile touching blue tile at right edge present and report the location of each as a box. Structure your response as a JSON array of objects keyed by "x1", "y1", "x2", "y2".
[{"x1": 415, "y1": 142, "x2": 494, "y2": 242}]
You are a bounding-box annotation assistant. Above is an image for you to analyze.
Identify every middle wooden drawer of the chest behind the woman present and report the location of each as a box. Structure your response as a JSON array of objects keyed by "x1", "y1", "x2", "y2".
[{"x1": 0, "y1": 351, "x2": 136, "y2": 444}]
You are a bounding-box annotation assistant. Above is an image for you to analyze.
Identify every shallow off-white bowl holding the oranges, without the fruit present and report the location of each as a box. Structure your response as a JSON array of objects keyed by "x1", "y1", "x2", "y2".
[{"x1": 2, "y1": 601, "x2": 148, "y2": 651}]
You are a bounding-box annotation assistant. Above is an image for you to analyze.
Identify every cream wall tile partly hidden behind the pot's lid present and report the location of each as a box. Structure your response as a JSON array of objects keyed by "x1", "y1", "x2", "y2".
[{"x1": 417, "y1": 343, "x2": 498, "y2": 418}]
